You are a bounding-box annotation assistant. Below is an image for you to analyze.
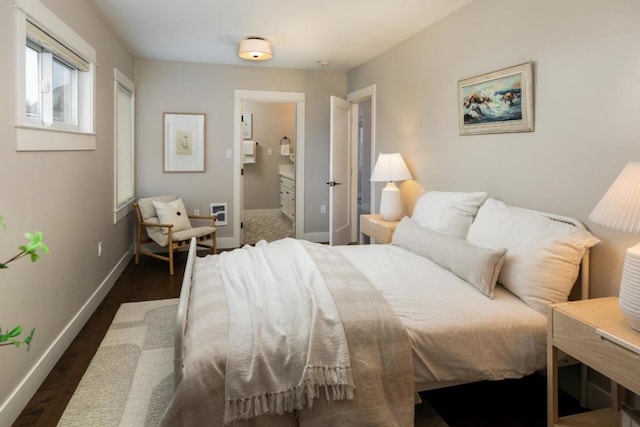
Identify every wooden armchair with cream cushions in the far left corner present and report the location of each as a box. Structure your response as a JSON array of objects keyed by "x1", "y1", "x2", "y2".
[{"x1": 133, "y1": 195, "x2": 217, "y2": 276}]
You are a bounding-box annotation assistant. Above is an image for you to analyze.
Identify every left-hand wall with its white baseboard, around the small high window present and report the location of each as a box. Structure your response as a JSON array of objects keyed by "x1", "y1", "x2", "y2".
[{"x1": 0, "y1": 0, "x2": 134, "y2": 425}]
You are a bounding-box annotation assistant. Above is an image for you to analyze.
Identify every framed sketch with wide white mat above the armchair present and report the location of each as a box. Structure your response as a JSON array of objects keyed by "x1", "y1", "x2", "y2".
[{"x1": 164, "y1": 113, "x2": 205, "y2": 172}]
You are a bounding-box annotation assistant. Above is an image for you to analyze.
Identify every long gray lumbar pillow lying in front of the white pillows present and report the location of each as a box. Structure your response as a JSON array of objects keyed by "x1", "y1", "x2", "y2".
[{"x1": 392, "y1": 217, "x2": 507, "y2": 298}]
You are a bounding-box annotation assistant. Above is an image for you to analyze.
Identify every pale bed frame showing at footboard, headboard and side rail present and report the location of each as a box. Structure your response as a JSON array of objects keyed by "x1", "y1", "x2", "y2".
[{"x1": 173, "y1": 208, "x2": 589, "y2": 392}]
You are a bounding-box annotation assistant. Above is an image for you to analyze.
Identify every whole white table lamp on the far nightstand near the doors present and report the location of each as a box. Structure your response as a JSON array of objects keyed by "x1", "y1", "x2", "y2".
[{"x1": 371, "y1": 153, "x2": 411, "y2": 221}]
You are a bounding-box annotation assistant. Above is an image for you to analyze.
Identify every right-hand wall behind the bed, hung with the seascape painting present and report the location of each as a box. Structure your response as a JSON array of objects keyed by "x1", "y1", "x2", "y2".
[{"x1": 348, "y1": 0, "x2": 640, "y2": 297}]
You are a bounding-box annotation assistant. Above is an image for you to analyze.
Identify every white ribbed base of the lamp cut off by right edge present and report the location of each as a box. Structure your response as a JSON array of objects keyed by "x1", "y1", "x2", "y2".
[{"x1": 618, "y1": 244, "x2": 640, "y2": 332}]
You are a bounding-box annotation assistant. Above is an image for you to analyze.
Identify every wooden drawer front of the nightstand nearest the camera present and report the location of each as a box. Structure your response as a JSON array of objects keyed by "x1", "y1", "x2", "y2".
[{"x1": 552, "y1": 309, "x2": 640, "y2": 393}]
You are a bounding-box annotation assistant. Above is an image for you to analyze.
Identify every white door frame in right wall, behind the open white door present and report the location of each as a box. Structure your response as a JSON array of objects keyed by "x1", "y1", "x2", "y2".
[{"x1": 347, "y1": 84, "x2": 376, "y2": 242}]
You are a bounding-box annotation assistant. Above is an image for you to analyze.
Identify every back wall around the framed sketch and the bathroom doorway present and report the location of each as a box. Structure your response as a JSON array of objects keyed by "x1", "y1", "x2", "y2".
[{"x1": 135, "y1": 59, "x2": 347, "y2": 238}]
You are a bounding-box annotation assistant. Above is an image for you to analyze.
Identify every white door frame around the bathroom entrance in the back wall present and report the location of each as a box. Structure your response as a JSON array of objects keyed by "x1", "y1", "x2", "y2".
[{"x1": 231, "y1": 90, "x2": 305, "y2": 247}]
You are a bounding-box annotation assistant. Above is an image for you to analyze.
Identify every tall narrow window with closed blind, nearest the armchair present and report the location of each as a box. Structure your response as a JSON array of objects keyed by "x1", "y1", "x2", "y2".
[{"x1": 114, "y1": 69, "x2": 135, "y2": 223}]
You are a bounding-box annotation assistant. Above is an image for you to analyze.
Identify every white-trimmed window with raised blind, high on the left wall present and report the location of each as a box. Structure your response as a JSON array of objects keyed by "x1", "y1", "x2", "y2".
[{"x1": 15, "y1": 0, "x2": 96, "y2": 151}]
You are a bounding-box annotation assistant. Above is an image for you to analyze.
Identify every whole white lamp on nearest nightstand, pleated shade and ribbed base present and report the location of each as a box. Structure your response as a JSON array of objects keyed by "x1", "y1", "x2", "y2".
[{"x1": 589, "y1": 162, "x2": 640, "y2": 332}]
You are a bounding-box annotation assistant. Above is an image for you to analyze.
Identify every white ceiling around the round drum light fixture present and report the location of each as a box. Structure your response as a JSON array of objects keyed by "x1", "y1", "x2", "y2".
[{"x1": 90, "y1": 0, "x2": 471, "y2": 71}]
